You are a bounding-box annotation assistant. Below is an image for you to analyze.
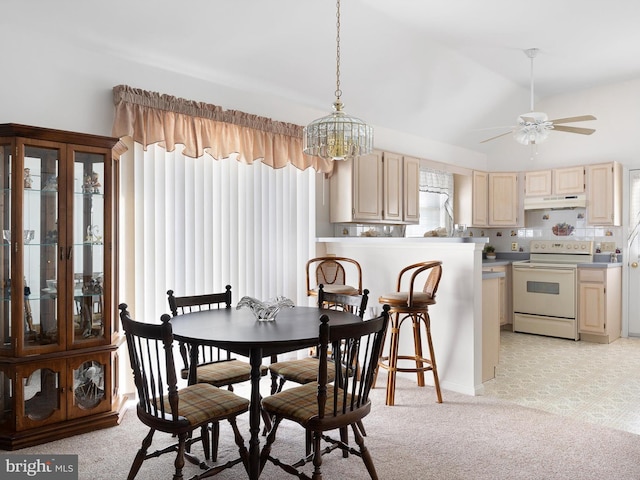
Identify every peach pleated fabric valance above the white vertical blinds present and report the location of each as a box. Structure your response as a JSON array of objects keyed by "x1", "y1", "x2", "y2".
[{"x1": 112, "y1": 85, "x2": 333, "y2": 173}]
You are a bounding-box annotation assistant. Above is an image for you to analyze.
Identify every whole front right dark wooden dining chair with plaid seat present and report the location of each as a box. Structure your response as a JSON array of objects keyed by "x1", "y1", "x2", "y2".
[{"x1": 260, "y1": 305, "x2": 389, "y2": 480}]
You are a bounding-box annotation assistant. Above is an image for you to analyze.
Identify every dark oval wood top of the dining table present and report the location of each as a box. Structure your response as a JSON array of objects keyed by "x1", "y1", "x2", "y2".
[{"x1": 171, "y1": 307, "x2": 362, "y2": 356}]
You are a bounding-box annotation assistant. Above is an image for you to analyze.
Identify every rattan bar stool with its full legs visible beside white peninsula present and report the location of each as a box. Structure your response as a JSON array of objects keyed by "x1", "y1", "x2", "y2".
[{"x1": 374, "y1": 261, "x2": 442, "y2": 405}]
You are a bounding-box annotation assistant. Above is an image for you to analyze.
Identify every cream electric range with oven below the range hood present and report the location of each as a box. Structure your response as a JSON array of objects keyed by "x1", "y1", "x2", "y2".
[{"x1": 512, "y1": 240, "x2": 593, "y2": 340}]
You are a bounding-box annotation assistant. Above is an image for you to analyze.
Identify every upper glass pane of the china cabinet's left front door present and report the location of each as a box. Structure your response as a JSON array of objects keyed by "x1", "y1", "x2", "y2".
[{"x1": 22, "y1": 145, "x2": 65, "y2": 351}]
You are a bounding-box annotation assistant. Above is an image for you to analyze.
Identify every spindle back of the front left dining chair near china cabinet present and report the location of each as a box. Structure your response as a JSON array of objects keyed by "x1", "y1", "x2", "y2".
[{"x1": 119, "y1": 303, "x2": 190, "y2": 433}]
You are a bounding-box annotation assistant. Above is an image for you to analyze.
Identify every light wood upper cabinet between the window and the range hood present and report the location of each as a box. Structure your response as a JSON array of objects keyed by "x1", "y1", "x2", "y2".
[{"x1": 453, "y1": 170, "x2": 520, "y2": 227}]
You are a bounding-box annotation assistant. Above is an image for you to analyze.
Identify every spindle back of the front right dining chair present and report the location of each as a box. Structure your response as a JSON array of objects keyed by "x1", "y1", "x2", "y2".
[{"x1": 309, "y1": 305, "x2": 389, "y2": 431}]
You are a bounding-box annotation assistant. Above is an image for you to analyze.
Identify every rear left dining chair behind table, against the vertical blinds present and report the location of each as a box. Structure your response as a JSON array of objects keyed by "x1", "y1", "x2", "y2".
[{"x1": 167, "y1": 285, "x2": 269, "y2": 462}]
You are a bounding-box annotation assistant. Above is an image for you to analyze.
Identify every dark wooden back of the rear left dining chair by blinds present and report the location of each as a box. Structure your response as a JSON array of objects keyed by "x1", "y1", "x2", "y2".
[{"x1": 167, "y1": 285, "x2": 234, "y2": 383}]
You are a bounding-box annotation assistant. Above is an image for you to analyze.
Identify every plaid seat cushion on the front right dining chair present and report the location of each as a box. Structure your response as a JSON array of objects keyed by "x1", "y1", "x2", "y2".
[{"x1": 262, "y1": 382, "x2": 360, "y2": 426}]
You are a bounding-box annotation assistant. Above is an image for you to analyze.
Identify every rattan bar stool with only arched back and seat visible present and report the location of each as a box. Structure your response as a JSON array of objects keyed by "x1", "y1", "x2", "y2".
[{"x1": 305, "y1": 256, "x2": 362, "y2": 296}]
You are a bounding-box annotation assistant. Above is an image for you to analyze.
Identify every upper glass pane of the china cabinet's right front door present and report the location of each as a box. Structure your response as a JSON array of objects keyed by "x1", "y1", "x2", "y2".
[{"x1": 71, "y1": 151, "x2": 107, "y2": 344}]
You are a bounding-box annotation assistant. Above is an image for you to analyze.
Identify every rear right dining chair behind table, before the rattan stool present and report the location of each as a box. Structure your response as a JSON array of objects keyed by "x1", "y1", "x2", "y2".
[{"x1": 269, "y1": 284, "x2": 369, "y2": 395}]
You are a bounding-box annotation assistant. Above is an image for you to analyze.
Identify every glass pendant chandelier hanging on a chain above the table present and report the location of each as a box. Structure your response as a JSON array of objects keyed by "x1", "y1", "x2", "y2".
[{"x1": 303, "y1": 0, "x2": 373, "y2": 160}]
